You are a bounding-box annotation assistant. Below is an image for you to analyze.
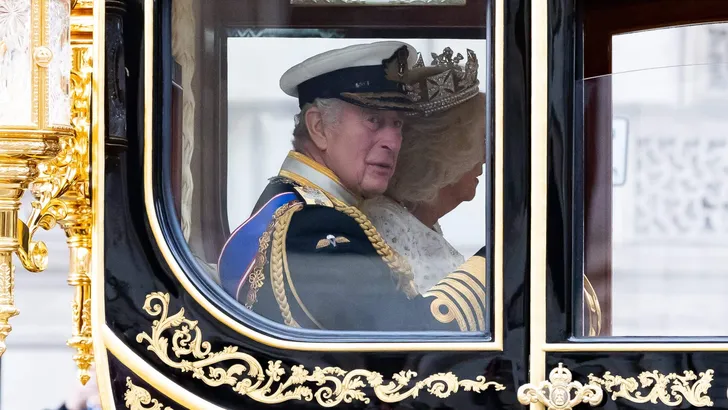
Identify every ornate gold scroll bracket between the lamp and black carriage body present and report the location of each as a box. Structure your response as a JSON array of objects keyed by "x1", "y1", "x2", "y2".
[{"x1": 18, "y1": 3, "x2": 93, "y2": 384}]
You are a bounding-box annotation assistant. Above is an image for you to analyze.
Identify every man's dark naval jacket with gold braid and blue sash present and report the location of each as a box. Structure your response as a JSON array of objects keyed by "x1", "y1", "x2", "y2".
[{"x1": 218, "y1": 152, "x2": 486, "y2": 331}]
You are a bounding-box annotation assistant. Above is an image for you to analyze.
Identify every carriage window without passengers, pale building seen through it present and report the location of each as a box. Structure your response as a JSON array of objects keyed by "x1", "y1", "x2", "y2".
[{"x1": 582, "y1": 23, "x2": 728, "y2": 336}]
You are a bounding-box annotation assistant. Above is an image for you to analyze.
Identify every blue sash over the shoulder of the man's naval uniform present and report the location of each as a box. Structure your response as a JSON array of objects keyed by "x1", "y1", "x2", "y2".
[{"x1": 217, "y1": 192, "x2": 297, "y2": 299}]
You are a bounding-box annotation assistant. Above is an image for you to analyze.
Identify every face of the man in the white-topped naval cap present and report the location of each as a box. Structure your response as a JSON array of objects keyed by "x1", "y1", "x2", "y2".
[{"x1": 323, "y1": 103, "x2": 402, "y2": 198}]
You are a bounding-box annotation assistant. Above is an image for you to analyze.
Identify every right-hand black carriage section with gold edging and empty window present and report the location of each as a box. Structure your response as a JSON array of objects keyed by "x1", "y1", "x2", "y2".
[{"x1": 518, "y1": 0, "x2": 728, "y2": 409}]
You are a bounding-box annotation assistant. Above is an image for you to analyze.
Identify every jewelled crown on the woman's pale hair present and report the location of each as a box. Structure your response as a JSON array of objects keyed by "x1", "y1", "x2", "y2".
[{"x1": 406, "y1": 47, "x2": 480, "y2": 115}]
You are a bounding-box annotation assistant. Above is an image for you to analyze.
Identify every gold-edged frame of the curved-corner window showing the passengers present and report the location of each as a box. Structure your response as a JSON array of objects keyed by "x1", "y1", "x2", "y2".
[{"x1": 144, "y1": 0, "x2": 503, "y2": 351}]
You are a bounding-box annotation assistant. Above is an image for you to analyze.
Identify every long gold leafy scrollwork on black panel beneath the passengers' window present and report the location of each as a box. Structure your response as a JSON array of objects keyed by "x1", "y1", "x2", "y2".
[{"x1": 136, "y1": 292, "x2": 506, "y2": 407}]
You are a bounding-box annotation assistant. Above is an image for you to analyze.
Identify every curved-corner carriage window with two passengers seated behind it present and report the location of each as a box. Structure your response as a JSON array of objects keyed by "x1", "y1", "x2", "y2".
[{"x1": 168, "y1": 0, "x2": 491, "y2": 339}]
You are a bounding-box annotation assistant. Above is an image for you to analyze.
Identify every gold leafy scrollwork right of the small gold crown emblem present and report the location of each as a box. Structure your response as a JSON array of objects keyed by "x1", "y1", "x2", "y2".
[{"x1": 589, "y1": 369, "x2": 715, "y2": 407}]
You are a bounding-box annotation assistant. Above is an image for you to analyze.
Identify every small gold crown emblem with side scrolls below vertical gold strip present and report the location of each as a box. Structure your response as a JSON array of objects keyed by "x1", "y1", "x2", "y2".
[{"x1": 518, "y1": 363, "x2": 602, "y2": 410}]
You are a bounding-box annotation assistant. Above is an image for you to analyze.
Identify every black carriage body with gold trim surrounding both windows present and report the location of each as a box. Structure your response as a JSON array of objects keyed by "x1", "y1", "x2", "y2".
[{"x1": 94, "y1": 0, "x2": 728, "y2": 409}]
